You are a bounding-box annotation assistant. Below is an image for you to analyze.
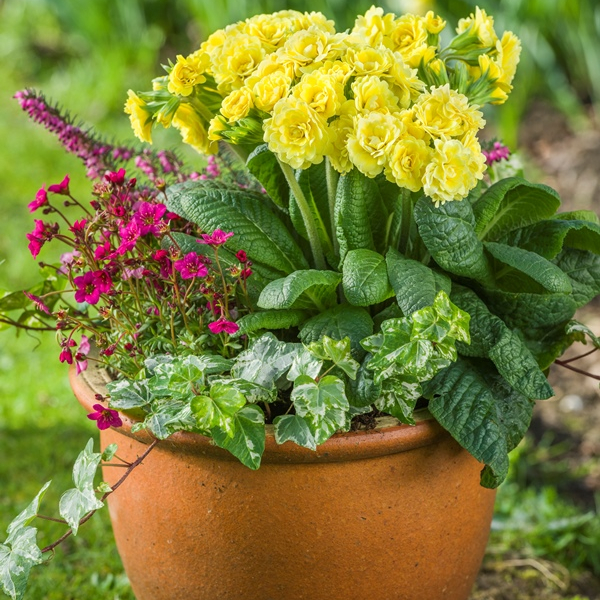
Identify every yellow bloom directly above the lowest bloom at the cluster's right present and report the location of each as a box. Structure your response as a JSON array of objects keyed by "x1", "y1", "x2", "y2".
[{"x1": 414, "y1": 84, "x2": 485, "y2": 138}]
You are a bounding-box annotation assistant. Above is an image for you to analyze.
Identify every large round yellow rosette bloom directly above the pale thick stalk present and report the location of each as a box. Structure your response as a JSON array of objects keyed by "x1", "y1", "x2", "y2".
[{"x1": 263, "y1": 96, "x2": 330, "y2": 169}]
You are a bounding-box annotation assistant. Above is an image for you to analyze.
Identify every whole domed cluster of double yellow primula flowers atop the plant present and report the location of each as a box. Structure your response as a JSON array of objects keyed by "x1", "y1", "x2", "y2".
[{"x1": 126, "y1": 7, "x2": 520, "y2": 203}]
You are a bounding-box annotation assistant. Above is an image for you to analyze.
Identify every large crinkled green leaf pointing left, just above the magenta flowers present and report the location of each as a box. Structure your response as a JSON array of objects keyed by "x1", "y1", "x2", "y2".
[{"x1": 167, "y1": 181, "x2": 308, "y2": 274}]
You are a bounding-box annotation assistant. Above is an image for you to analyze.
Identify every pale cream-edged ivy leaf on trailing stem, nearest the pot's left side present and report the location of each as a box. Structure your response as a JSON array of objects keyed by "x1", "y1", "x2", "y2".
[{"x1": 59, "y1": 439, "x2": 104, "y2": 535}]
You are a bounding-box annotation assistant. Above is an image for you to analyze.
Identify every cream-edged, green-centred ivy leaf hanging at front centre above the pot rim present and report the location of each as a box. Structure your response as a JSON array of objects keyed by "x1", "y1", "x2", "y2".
[{"x1": 291, "y1": 375, "x2": 350, "y2": 444}]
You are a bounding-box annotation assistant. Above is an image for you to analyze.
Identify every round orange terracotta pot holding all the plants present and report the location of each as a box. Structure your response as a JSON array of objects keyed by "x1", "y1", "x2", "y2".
[{"x1": 71, "y1": 360, "x2": 494, "y2": 600}]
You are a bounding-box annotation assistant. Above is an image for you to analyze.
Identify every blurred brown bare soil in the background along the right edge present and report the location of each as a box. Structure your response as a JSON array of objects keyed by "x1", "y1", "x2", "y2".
[{"x1": 470, "y1": 103, "x2": 600, "y2": 600}]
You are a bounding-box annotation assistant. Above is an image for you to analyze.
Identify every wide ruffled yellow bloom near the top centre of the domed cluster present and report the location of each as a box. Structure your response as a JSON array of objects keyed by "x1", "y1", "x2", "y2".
[{"x1": 277, "y1": 26, "x2": 342, "y2": 77}]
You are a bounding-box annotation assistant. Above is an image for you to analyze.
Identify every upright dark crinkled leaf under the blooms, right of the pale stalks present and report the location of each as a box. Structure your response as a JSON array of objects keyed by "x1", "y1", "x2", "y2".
[{"x1": 334, "y1": 169, "x2": 387, "y2": 261}]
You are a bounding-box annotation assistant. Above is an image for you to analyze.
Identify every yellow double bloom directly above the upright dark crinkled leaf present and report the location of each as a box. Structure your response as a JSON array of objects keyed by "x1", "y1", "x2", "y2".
[{"x1": 347, "y1": 113, "x2": 404, "y2": 177}]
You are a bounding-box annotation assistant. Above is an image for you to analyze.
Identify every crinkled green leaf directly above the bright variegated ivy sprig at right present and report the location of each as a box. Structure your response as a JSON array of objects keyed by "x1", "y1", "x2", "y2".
[{"x1": 386, "y1": 248, "x2": 451, "y2": 316}]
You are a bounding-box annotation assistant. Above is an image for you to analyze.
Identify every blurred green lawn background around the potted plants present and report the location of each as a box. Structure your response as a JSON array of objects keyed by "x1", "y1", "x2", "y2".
[{"x1": 0, "y1": 0, "x2": 600, "y2": 600}]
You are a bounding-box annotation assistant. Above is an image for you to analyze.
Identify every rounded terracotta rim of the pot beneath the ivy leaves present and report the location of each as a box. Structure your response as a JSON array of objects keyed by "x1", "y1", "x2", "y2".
[{"x1": 69, "y1": 356, "x2": 450, "y2": 464}]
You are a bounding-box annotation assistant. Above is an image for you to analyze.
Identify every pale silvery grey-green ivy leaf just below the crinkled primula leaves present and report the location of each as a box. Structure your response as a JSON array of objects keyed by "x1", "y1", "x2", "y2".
[{"x1": 231, "y1": 333, "x2": 302, "y2": 388}]
